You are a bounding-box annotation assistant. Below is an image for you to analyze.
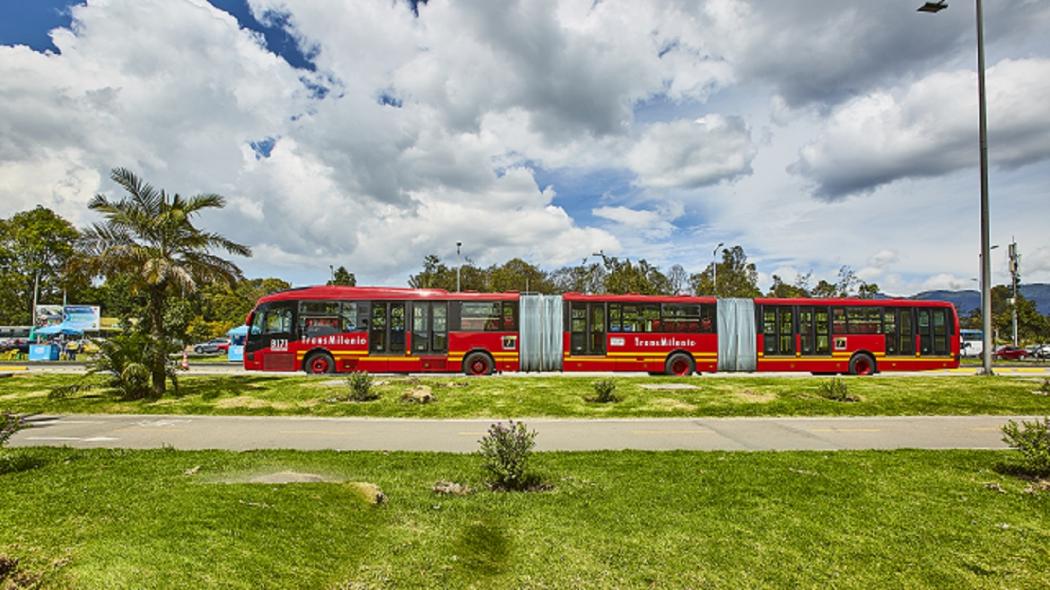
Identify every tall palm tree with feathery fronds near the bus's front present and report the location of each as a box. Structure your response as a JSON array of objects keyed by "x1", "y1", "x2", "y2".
[{"x1": 80, "y1": 168, "x2": 252, "y2": 396}]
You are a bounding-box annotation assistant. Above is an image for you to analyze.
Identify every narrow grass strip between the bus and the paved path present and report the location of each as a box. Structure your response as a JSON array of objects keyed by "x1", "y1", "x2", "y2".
[{"x1": 0, "y1": 374, "x2": 1050, "y2": 418}]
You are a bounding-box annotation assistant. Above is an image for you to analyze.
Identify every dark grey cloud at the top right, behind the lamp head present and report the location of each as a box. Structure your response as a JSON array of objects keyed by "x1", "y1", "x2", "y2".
[{"x1": 696, "y1": 0, "x2": 1050, "y2": 107}]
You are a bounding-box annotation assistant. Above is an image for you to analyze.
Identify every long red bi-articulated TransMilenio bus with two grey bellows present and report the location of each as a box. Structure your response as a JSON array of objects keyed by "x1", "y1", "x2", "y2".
[{"x1": 244, "y1": 287, "x2": 960, "y2": 376}]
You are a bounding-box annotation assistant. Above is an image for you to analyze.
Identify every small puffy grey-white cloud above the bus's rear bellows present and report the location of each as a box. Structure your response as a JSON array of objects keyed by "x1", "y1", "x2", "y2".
[{"x1": 627, "y1": 114, "x2": 755, "y2": 188}]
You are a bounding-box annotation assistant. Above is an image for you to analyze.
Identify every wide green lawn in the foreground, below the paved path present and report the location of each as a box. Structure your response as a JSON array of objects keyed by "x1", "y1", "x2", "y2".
[{"x1": 0, "y1": 448, "x2": 1050, "y2": 589}]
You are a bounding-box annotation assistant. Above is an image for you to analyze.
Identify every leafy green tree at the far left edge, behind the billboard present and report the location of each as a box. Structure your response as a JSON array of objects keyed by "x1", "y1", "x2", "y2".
[{"x1": 0, "y1": 206, "x2": 82, "y2": 324}]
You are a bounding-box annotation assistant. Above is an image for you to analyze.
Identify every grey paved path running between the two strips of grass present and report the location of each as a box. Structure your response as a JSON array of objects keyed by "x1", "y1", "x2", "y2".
[{"x1": 4, "y1": 415, "x2": 1031, "y2": 452}]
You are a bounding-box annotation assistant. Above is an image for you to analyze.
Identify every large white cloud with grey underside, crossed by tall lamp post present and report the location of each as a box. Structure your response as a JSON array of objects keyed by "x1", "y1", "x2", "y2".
[{"x1": 791, "y1": 59, "x2": 1050, "y2": 199}]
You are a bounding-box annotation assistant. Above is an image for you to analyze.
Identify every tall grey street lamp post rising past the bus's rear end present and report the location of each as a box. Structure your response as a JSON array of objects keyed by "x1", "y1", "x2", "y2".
[{"x1": 919, "y1": 0, "x2": 992, "y2": 375}]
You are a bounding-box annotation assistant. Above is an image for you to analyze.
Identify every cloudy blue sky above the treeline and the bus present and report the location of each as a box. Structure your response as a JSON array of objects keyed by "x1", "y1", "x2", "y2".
[{"x1": 0, "y1": 0, "x2": 1050, "y2": 294}]
